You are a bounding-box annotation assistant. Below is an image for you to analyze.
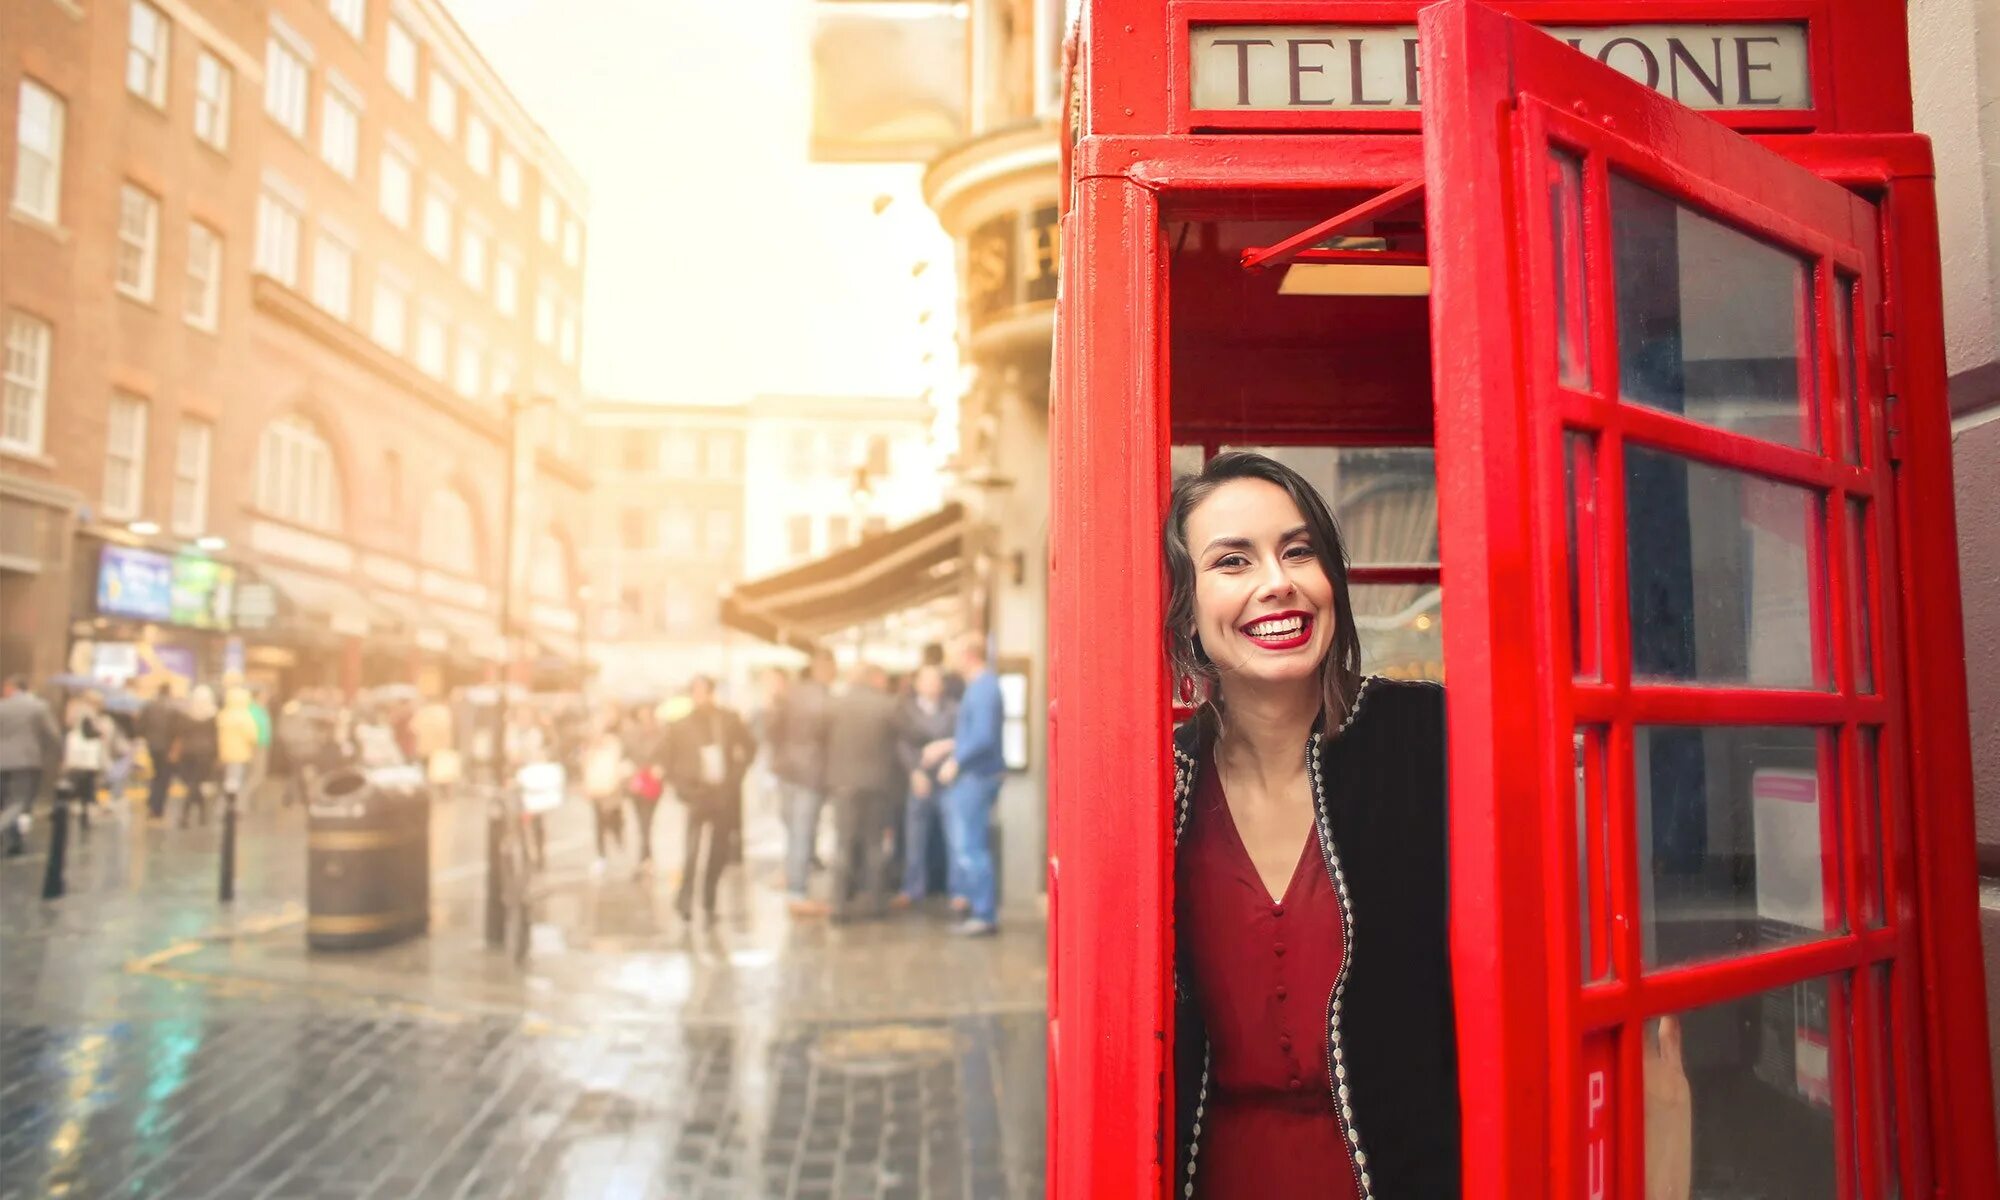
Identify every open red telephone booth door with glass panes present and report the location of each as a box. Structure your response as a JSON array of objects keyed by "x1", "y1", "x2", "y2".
[{"x1": 1420, "y1": 0, "x2": 1994, "y2": 1198}]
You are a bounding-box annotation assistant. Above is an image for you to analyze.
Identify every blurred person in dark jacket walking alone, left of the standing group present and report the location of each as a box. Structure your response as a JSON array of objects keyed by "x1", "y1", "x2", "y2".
[{"x1": 666, "y1": 676, "x2": 756, "y2": 922}]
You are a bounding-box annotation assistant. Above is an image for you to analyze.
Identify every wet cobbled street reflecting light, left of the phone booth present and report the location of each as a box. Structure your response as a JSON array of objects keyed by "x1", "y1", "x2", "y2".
[{"x1": 0, "y1": 784, "x2": 1046, "y2": 1200}]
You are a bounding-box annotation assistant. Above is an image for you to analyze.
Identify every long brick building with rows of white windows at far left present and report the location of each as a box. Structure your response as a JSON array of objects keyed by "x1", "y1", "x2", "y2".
[{"x1": 0, "y1": 0, "x2": 588, "y2": 686}]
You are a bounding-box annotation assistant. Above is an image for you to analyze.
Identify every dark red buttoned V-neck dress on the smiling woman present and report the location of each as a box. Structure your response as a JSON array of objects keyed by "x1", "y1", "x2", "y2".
[{"x1": 1174, "y1": 762, "x2": 1356, "y2": 1200}]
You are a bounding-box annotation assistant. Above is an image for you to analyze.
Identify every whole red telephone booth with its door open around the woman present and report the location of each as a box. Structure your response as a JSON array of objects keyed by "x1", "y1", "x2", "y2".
[{"x1": 1048, "y1": 0, "x2": 2000, "y2": 1200}]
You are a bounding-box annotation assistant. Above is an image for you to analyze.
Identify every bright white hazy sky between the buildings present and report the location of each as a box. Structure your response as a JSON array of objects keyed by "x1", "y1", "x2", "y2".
[{"x1": 446, "y1": 0, "x2": 956, "y2": 408}]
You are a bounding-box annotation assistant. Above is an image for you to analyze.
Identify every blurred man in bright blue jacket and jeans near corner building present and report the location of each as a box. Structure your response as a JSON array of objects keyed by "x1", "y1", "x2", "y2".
[{"x1": 938, "y1": 632, "x2": 1006, "y2": 938}]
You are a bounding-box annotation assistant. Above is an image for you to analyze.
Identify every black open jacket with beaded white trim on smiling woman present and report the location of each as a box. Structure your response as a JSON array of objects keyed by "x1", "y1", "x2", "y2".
[{"x1": 1174, "y1": 676, "x2": 1460, "y2": 1200}]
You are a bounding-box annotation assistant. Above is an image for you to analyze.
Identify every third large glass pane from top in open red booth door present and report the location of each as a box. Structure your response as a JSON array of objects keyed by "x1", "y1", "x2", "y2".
[{"x1": 1632, "y1": 726, "x2": 1846, "y2": 968}]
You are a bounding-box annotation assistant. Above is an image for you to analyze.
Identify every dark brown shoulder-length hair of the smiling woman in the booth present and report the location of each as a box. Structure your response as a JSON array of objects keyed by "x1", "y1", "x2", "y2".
[{"x1": 1160, "y1": 450, "x2": 1362, "y2": 740}]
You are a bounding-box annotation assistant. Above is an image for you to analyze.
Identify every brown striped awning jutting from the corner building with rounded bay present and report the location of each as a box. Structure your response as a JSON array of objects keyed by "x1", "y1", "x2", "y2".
[{"x1": 722, "y1": 504, "x2": 966, "y2": 650}]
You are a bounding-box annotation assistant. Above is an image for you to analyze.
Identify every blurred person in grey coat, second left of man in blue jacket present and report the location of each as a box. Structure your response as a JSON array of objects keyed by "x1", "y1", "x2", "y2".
[{"x1": 826, "y1": 662, "x2": 902, "y2": 920}]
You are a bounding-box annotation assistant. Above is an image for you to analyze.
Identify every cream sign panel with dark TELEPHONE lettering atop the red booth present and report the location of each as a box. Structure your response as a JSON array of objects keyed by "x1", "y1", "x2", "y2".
[{"x1": 1190, "y1": 22, "x2": 1812, "y2": 112}]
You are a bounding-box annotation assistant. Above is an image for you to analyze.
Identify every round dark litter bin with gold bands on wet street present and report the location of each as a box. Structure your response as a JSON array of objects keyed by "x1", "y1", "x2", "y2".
[{"x1": 306, "y1": 766, "x2": 430, "y2": 950}]
